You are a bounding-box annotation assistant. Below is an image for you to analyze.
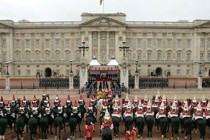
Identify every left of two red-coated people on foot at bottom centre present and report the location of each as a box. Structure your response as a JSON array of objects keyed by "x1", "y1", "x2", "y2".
[{"x1": 84, "y1": 120, "x2": 95, "y2": 140}]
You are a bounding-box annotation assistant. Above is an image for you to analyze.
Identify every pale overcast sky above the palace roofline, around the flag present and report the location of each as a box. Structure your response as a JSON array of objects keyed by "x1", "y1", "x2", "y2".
[{"x1": 0, "y1": 0, "x2": 210, "y2": 21}]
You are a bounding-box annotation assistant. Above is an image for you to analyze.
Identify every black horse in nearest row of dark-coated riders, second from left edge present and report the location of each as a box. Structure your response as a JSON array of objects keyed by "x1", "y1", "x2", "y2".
[{"x1": 16, "y1": 114, "x2": 26, "y2": 140}]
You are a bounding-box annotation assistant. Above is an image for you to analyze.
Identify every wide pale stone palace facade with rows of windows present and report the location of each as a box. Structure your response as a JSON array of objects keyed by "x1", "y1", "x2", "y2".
[{"x1": 0, "y1": 13, "x2": 210, "y2": 77}]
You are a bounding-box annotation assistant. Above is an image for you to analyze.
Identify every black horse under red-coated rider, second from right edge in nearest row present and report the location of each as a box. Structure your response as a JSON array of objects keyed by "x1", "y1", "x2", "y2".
[{"x1": 195, "y1": 118, "x2": 206, "y2": 140}]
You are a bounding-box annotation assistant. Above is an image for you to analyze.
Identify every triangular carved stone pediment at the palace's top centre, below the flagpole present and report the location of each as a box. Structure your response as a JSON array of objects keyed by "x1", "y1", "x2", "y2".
[{"x1": 80, "y1": 17, "x2": 126, "y2": 27}]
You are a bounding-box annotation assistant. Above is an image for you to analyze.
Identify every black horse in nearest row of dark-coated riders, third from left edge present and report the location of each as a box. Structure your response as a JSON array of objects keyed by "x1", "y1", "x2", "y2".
[{"x1": 28, "y1": 116, "x2": 38, "y2": 140}]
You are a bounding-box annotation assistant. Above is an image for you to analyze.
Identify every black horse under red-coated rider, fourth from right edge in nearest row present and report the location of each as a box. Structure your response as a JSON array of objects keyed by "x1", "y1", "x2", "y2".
[{"x1": 171, "y1": 116, "x2": 180, "y2": 139}]
